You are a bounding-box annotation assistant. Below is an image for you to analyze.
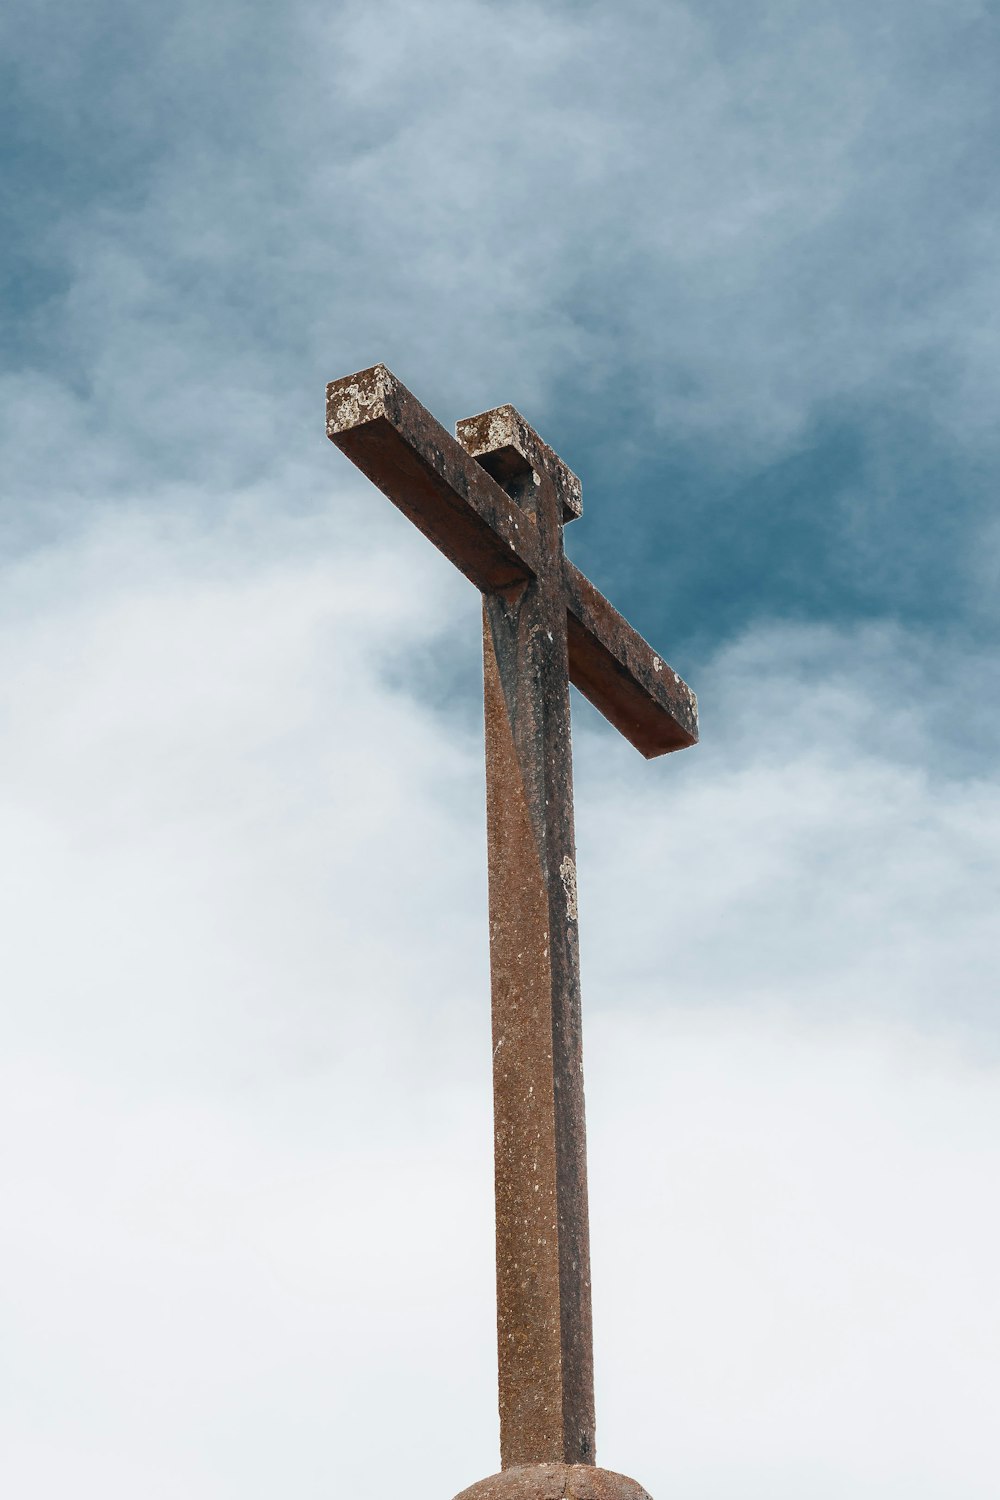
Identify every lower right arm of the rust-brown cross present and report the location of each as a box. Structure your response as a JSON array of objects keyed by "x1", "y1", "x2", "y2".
[{"x1": 562, "y1": 558, "x2": 699, "y2": 761}]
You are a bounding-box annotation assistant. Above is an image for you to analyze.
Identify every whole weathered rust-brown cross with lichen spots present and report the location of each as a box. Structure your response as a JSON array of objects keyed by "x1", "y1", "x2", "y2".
[{"x1": 327, "y1": 365, "x2": 697, "y2": 1494}]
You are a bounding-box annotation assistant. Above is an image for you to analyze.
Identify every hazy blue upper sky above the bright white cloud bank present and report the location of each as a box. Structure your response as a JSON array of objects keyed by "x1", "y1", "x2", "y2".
[{"x1": 0, "y1": 3, "x2": 1000, "y2": 690}]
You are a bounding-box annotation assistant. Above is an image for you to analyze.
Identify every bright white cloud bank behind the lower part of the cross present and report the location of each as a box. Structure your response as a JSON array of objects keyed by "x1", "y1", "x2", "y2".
[{"x1": 0, "y1": 507, "x2": 1000, "y2": 1500}]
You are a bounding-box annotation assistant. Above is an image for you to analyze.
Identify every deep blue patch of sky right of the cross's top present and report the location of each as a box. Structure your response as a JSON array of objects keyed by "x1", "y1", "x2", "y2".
[{"x1": 567, "y1": 396, "x2": 996, "y2": 666}]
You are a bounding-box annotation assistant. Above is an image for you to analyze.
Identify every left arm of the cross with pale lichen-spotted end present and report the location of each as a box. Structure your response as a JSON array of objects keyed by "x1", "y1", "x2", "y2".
[{"x1": 327, "y1": 365, "x2": 538, "y2": 591}]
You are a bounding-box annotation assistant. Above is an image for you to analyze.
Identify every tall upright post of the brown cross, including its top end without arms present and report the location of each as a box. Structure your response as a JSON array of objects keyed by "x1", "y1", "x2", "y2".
[{"x1": 457, "y1": 407, "x2": 595, "y2": 1469}]
